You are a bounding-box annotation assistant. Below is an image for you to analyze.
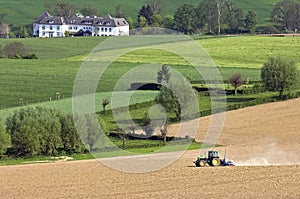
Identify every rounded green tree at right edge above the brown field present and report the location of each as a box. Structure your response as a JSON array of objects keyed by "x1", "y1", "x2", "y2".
[{"x1": 261, "y1": 57, "x2": 298, "y2": 98}]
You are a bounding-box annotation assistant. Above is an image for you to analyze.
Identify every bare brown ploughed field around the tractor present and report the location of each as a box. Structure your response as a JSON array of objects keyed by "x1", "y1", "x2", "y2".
[{"x1": 0, "y1": 99, "x2": 300, "y2": 198}]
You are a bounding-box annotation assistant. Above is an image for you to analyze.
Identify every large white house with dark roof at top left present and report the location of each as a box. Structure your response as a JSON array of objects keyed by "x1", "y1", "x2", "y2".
[{"x1": 33, "y1": 12, "x2": 129, "y2": 37}]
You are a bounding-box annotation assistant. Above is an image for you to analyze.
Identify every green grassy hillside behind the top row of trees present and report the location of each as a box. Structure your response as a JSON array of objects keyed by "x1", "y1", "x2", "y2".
[{"x1": 0, "y1": 0, "x2": 280, "y2": 24}]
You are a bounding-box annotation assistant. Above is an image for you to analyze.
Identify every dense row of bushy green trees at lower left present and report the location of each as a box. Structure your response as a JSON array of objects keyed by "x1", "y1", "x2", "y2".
[{"x1": 0, "y1": 106, "x2": 102, "y2": 157}]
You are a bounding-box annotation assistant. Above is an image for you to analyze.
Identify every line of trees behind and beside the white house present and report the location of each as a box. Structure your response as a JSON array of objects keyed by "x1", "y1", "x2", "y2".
[{"x1": 0, "y1": 0, "x2": 300, "y2": 37}]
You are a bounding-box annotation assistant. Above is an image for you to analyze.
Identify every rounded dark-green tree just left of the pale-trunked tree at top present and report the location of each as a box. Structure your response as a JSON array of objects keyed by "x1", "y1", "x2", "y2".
[{"x1": 174, "y1": 4, "x2": 196, "y2": 34}]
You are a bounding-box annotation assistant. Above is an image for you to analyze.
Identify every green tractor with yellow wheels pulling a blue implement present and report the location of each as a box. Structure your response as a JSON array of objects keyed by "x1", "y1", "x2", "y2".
[{"x1": 194, "y1": 150, "x2": 235, "y2": 167}]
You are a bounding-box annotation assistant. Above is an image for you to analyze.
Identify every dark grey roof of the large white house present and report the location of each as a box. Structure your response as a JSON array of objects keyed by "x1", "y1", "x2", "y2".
[{"x1": 35, "y1": 12, "x2": 128, "y2": 27}]
